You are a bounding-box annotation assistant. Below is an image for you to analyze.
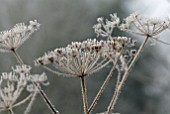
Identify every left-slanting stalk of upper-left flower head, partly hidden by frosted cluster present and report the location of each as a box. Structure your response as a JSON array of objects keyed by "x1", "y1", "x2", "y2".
[{"x1": 12, "y1": 50, "x2": 59, "y2": 114}]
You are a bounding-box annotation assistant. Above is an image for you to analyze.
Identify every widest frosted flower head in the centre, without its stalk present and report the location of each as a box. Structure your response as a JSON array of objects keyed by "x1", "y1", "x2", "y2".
[{"x1": 35, "y1": 39, "x2": 112, "y2": 77}]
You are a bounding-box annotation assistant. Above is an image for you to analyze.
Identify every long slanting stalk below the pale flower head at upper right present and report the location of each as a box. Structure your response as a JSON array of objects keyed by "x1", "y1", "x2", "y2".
[{"x1": 106, "y1": 36, "x2": 149, "y2": 114}]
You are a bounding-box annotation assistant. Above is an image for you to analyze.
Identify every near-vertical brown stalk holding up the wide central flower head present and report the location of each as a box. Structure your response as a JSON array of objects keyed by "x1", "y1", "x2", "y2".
[{"x1": 80, "y1": 76, "x2": 89, "y2": 114}]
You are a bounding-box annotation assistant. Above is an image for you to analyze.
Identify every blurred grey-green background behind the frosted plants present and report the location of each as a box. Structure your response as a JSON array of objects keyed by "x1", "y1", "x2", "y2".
[{"x1": 0, "y1": 0, "x2": 170, "y2": 114}]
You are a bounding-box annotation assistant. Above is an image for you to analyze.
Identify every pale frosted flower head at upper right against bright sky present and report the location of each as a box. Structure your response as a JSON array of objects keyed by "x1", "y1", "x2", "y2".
[{"x1": 120, "y1": 13, "x2": 170, "y2": 39}]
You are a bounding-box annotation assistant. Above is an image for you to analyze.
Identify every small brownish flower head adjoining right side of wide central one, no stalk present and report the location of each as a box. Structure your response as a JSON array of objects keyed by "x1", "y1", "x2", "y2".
[{"x1": 105, "y1": 36, "x2": 135, "y2": 71}]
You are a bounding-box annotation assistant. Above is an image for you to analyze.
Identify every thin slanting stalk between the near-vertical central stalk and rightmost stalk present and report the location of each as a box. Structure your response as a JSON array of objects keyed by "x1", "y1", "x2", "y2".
[{"x1": 88, "y1": 49, "x2": 124, "y2": 113}]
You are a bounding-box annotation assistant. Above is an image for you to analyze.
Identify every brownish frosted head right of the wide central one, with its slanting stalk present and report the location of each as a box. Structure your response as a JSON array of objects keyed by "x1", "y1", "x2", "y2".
[{"x1": 88, "y1": 37, "x2": 136, "y2": 112}]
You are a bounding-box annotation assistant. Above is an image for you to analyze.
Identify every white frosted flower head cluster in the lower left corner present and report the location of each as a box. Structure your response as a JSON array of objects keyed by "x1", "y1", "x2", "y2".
[{"x1": 0, "y1": 65, "x2": 47, "y2": 114}]
